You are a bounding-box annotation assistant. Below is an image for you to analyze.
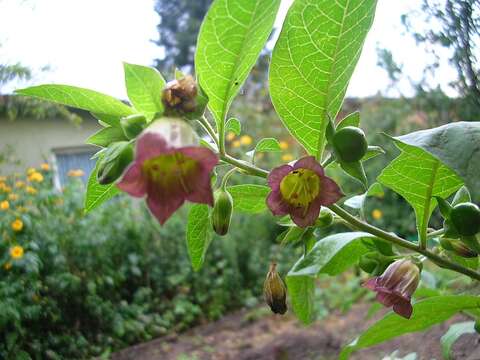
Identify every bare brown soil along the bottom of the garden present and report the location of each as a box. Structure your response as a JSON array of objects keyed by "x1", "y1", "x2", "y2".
[{"x1": 112, "y1": 305, "x2": 480, "y2": 360}]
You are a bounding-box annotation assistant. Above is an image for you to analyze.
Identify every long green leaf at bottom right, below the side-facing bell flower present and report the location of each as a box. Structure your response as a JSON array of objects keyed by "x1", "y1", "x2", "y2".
[{"x1": 339, "y1": 295, "x2": 480, "y2": 360}]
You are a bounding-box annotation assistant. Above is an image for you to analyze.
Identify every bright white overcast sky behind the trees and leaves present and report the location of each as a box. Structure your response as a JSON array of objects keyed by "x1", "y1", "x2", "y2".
[{"x1": 0, "y1": 0, "x2": 455, "y2": 99}]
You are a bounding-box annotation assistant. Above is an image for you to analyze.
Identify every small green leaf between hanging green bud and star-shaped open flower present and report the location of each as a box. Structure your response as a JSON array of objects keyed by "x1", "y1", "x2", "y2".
[{"x1": 228, "y1": 185, "x2": 270, "y2": 214}]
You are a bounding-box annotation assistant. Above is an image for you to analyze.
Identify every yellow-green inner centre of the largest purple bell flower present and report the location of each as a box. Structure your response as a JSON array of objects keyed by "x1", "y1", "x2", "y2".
[{"x1": 142, "y1": 153, "x2": 198, "y2": 193}]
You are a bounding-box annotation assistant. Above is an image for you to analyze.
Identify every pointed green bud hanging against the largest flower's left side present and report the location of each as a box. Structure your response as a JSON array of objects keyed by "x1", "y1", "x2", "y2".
[{"x1": 97, "y1": 141, "x2": 133, "y2": 185}]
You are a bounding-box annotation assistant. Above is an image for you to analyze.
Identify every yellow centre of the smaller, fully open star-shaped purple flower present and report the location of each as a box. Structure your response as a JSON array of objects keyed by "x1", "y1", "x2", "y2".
[{"x1": 280, "y1": 169, "x2": 320, "y2": 208}]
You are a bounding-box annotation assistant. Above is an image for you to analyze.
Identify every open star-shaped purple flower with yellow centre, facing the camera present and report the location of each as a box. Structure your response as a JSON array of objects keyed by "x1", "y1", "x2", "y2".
[{"x1": 267, "y1": 156, "x2": 343, "y2": 227}]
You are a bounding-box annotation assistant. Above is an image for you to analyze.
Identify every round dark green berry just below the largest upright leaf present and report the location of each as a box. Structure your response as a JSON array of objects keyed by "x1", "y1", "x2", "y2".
[{"x1": 332, "y1": 126, "x2": 368, "y2": 162}]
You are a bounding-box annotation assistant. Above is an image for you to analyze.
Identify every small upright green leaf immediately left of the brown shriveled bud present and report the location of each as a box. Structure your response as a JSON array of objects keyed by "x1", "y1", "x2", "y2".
[{"x1": 123, "y1": 63, "x2": 165, "y2": 120}]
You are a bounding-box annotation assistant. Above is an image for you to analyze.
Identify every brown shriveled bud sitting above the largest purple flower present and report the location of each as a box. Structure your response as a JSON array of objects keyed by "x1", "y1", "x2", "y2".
[{"x1": 162, "y1": 75, "x2": 197, "y2": 115}]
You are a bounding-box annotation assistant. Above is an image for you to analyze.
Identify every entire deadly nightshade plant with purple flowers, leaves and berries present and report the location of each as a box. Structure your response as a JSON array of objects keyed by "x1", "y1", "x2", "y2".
[{"x1": 13, "y1": 0, "x2": 480, "y2": 360}]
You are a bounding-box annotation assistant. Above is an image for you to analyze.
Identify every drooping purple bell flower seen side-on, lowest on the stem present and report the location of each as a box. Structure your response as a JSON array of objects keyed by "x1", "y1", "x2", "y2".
[{"x1": 363, "y1": 259, "x2": 420, "y2": 319}]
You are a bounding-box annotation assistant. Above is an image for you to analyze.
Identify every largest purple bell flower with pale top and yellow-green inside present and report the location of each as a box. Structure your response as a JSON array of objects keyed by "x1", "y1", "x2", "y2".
[{"x1": 117, "y1": 118, "x2": 218, "y2": 224}]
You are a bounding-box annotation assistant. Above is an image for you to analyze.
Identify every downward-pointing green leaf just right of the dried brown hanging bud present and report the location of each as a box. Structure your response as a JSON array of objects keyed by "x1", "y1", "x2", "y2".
[{"x1": 285, "y1": 276, "x2": 315, "y2": 325}]
